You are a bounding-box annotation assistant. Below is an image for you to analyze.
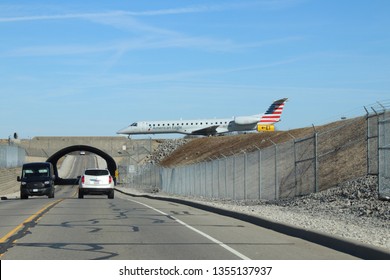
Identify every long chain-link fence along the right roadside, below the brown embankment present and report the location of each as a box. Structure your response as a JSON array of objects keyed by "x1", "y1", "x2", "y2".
[{"x1": 119, "y1": 117, "x2": 378, "y2": 200}]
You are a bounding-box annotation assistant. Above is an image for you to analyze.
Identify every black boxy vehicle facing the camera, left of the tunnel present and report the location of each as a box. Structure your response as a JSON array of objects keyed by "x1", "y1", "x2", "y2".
[{"x1": 17, "y1": 162, "x2": 55, "y2": 199}]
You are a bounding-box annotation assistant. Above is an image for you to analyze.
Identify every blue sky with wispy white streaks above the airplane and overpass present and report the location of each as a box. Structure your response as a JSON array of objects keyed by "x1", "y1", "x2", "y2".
[{"x1": 0, "y1": 0, "x2": 390, "y2": 138}]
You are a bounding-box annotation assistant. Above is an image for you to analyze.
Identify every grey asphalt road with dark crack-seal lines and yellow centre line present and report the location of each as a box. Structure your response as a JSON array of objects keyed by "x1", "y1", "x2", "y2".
[{"x1": 0, "y1": 155, "x2": 356, "y2": 260}]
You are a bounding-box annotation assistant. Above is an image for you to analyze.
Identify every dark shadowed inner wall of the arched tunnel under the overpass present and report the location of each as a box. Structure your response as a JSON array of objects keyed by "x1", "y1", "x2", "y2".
[{"x1": 46, "y1": 145, "x2": 118, "y2": 185}]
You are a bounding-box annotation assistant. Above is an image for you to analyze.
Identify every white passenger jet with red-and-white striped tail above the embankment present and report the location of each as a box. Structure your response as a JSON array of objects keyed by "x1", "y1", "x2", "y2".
[{"x1": 117, "y1": 98, "x2": 287, "y2": 136}]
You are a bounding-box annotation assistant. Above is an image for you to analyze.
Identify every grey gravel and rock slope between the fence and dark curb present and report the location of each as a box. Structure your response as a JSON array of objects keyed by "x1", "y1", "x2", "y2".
[{"x1": 207, "y1": 176, "x2": 390, "y2": 251}]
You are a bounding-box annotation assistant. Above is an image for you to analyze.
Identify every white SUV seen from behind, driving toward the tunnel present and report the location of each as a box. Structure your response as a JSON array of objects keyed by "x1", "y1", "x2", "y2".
[{"x1": 79, "y1": 168, "x2": 115, "y2": 199}]
